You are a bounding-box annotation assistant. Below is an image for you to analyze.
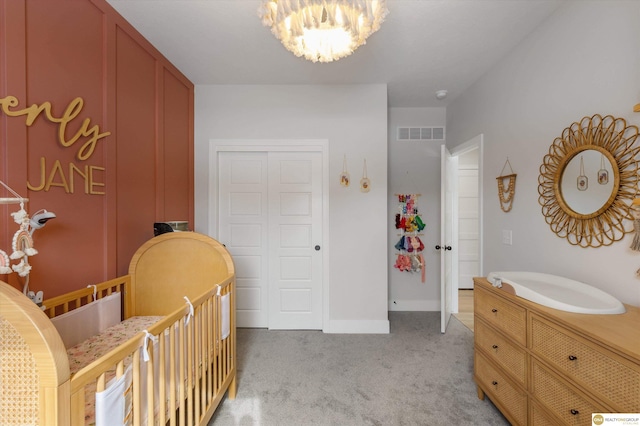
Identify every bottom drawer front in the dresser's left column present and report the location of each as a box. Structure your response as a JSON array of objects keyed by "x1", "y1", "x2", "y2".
[{"x1": 474, "y1": 351, "x2": 527, "y2": 425}]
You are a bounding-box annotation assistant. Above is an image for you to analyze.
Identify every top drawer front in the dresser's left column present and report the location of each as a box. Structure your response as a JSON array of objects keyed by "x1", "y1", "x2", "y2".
[{"x1": 474, "y1": 287, "x2": 527, "y2": 346}]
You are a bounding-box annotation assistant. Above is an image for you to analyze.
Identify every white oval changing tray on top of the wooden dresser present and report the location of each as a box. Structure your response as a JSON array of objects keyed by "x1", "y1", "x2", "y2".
[{"x1": 487, "y1": 271, "x2": 626, "y2": 314}]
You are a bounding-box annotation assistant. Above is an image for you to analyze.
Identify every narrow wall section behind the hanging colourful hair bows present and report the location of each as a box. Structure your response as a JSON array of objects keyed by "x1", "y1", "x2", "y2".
[{"x1": 387, "y1": 108, "x2": 446, "y2": 311}]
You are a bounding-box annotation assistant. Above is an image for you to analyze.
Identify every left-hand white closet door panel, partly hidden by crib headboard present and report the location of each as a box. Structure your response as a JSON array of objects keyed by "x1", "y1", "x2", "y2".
[{"x1": 218, "y1": 152, "x2": 269, "y2": 327}]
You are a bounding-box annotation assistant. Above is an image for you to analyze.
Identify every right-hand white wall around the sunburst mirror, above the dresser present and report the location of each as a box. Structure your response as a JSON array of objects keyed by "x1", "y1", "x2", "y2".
[{"x1": 447, "y1": 1, "x2": 640, "y2": 306}]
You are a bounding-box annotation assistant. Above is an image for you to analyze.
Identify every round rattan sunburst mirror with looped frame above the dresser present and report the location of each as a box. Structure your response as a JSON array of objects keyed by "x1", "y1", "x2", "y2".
[{"x1": 538, "y1": 114, "x2": 640, "y2": 247}]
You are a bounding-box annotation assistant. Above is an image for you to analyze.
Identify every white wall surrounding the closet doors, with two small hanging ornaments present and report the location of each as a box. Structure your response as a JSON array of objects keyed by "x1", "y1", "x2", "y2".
[{"x1": 195, "y1": 84, "x2": 389, "y2": 333}]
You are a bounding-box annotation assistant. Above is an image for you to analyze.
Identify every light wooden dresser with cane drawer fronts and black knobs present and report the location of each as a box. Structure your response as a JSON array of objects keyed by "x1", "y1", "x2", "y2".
[{"x1": 474, "y1": 278, "x2": 640, "y2": 426}]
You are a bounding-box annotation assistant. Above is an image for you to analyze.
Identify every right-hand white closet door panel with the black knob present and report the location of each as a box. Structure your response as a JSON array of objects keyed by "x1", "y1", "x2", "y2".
[{"x1": 269, "y1": 152, "x2": 322, "y2": 330}]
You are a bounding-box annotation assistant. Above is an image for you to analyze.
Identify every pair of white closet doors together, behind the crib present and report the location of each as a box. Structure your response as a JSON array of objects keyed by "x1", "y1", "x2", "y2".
[{"x1": 210, "y1": 143, "x2": 326, "y2": 330}]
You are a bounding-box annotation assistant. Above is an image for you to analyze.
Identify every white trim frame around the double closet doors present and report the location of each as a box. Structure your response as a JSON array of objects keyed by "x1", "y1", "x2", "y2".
[{"x1": 208, "y1": 139, "x2": 331, "y2": 332}]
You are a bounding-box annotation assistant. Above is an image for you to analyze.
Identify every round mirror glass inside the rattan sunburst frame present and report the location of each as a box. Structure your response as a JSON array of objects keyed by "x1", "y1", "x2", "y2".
[{"x1": 560, "y1": 149, "x2": 616, "y2": 215}]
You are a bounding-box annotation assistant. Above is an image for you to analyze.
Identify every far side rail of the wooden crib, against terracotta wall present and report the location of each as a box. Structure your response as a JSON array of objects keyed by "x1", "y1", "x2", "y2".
[{"x1": 42, "y1": 275, "x2": 131, "y2": 319}]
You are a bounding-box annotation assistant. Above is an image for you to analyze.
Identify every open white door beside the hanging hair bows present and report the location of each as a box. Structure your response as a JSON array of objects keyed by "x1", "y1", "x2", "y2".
[{"x1": 436, "y1": 145, "x2": 458, "y2": 333}]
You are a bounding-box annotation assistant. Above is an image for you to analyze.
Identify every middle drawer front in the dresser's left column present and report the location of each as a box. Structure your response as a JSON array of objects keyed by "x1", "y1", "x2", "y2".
[{"x1": 475, "y1": 319, "x2": 527, "y2": 387}]
